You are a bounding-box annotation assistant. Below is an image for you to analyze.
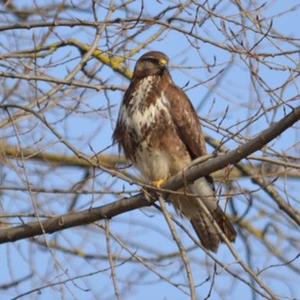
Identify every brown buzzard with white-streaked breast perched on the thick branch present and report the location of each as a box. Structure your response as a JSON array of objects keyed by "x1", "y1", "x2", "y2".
[{"x1": 113, "y1": 51, "x2": 236, "y2": 251}]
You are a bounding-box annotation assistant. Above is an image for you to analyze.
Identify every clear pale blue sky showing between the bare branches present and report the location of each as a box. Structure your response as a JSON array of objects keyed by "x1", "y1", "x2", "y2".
[{"x1": 0, "y1": 0, "x2": 300, "y2": 300}]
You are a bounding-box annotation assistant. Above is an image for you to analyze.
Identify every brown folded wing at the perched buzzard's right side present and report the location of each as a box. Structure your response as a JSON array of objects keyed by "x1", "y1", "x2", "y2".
[{"x1": 164, "y1": 84, "x2": 207, "y2": 160}]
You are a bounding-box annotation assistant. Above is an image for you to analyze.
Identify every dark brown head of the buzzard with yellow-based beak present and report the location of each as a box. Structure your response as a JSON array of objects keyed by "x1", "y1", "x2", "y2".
[{"x1": 133, "y1": 51, "x2": 169, "y2": 78}]
